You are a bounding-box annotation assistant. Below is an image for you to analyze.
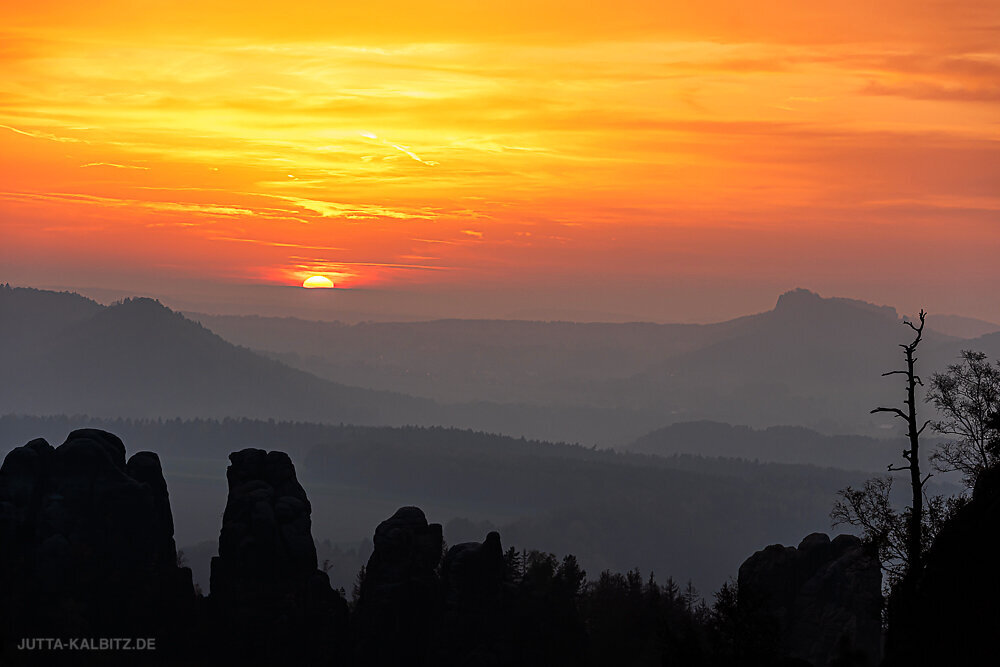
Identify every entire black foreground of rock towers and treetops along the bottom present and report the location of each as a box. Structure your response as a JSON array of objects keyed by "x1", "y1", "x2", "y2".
[{"x1": 0, "y1": 429, "x2": 908, "y2": 667}]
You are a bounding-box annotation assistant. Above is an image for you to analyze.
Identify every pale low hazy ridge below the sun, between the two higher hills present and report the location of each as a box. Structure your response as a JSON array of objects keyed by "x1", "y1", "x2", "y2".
[{"x1": 190, "y1": 314, "x2": 726, "y2": 405}]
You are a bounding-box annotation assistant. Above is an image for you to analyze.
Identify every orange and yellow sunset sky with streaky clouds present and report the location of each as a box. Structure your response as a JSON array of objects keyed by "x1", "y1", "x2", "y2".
[{"x1": 0, "y1": 0, "x2": 1000, "y2": 321}]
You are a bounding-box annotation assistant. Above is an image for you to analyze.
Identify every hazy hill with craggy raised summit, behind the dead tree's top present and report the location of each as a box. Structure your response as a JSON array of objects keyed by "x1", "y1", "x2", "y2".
[{"x1": 605, "y1": 290, "x2": 953, "y2": 433}]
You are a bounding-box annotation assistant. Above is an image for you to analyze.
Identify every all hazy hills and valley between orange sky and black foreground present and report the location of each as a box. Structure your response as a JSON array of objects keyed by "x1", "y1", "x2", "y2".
[{"x1": 0, "y1": 287, "x2": 984, "y2": 590}]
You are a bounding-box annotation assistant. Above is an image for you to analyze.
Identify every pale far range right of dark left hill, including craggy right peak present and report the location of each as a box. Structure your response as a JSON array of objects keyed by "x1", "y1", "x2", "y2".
[{"x1": 186, "y1": 289, "x2": 971, "y2": 444}]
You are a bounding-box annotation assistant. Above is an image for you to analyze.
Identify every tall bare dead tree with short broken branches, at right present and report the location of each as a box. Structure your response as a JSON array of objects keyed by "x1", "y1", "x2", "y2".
[{"x1": 872, "y1": 310, "x2": 930, "y2": 573}]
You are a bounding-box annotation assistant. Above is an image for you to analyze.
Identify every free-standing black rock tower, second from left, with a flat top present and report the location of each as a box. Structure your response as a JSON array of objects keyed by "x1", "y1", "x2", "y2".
[{"x1": 208, "y1": 449, "x2": 348, "y2": 665}]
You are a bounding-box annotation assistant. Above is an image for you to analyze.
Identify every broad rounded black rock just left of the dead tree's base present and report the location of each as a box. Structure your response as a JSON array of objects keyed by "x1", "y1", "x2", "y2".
[{"x1": 739, "y1": 533, "x2": 882, "y2": 667}]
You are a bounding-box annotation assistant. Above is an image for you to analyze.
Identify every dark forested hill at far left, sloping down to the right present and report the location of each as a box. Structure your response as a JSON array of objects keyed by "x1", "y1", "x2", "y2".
[{"x1": 0, "y1": 289, "x2": 435, "y2": 424}]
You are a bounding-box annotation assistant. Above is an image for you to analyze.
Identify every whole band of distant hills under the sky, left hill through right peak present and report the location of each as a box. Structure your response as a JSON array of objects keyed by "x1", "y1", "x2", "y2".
[{"x1": 0, "y1": 287, "x2": 1000, "y2": 446}]
